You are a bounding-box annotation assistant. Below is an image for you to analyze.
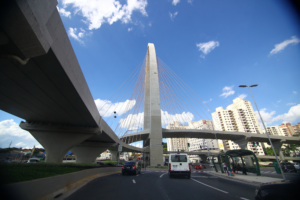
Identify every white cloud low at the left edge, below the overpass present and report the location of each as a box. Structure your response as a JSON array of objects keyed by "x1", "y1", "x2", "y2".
[{"x1": 0, "y1": 119, "x2": 41, "y2": 148}]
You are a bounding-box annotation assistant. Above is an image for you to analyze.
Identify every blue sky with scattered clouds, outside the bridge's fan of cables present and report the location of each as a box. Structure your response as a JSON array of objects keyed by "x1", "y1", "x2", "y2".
[{"x1": 0, "y1": 0, "x2": 300, "y2": 148}]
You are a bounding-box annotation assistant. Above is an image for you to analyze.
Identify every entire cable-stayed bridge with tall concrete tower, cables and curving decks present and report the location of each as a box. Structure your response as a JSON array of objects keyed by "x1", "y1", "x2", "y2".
[{"x1": 0, "y1": 0, "x2": 300, "y2": 165}]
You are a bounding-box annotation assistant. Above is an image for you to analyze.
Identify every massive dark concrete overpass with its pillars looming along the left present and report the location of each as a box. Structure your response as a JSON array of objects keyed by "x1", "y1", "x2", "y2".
[{"x1": 0, "y1": 0, "x2": 142, "y2": 162}]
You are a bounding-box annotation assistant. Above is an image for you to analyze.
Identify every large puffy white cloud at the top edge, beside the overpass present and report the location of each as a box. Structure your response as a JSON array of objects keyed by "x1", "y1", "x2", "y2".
[{"x1": 62, "y1": 0, "x2": 148, "y2": 30}]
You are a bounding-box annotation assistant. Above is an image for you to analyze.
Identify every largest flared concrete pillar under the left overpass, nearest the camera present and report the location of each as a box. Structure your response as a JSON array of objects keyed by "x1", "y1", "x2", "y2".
[{"x1": 20, "y1": 122, "x2": 94, "y2": 163}]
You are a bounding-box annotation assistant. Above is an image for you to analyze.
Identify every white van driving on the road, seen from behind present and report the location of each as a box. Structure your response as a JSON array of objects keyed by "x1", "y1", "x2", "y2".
[{"x1": 169, "y1": 153, "x2": 191, "y2": 178}]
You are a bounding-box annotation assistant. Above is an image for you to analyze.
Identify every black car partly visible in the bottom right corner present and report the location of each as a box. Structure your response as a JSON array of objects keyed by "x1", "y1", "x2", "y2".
[{"x1": 255, "y1": 179, "x2": 300, "y2": 200}]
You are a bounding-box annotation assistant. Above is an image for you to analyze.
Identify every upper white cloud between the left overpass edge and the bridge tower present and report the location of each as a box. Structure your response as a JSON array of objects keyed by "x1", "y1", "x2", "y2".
[{"x1": 95, "y1": 99, "x2": 136, "y2": 117}]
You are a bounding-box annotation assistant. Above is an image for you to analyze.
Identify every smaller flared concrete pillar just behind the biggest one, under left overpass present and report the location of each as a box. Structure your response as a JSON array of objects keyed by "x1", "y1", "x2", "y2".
[{"x1": 71, "y1": 145, "x2": 107, "y2": 163}]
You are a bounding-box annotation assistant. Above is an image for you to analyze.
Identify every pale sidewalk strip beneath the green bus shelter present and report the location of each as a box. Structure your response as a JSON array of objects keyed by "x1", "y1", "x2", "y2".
[{"x1": 206, "y1": 171, "x2": 282, "y2": 186}]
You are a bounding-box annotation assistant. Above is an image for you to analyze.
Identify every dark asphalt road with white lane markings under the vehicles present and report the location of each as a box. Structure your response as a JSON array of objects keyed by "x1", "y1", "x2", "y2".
[{"x1": 66, "y1": 170, "x2": 255, "y2": 200}]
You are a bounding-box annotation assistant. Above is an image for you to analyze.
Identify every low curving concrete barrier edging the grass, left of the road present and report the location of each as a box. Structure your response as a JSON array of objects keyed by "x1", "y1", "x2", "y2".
[{"x1": 1, "y1": 167, "x2": 121, "y2": 200}]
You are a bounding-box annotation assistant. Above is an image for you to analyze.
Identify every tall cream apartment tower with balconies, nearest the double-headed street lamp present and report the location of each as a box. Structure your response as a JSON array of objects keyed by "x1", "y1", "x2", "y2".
[{"x1": 212, "y1": 97, "x2": 264, "y2": 155}]
